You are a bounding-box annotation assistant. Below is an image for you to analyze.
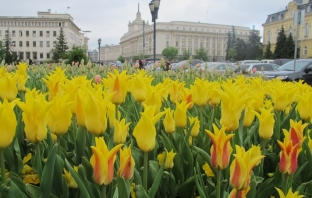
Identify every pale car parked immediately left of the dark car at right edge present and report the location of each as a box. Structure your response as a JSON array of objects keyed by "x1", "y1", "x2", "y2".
[{"x1": 234, "y1": 63, "x2": 274, "y2": 74}]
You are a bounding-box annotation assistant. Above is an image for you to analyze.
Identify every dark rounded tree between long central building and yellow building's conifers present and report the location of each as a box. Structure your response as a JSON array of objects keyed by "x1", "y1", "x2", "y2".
[{"x1": 246, "y1": 28, "x2": 263, "y2": 60}]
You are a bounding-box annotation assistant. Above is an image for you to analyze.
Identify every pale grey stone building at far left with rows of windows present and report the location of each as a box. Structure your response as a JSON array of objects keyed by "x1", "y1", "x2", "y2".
[{"x1": 0, "y1": 9, "x2": 88, "y2": 63}]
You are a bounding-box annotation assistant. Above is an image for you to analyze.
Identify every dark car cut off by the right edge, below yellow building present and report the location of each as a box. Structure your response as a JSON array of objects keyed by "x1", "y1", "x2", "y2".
[{"x1": 265, "y1": 59, "x2": 312, "y2": 85}]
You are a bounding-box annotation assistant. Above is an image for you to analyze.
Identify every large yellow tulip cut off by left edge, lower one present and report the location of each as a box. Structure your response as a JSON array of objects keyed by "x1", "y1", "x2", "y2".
[{"x1": 0, "y1": 99, "x2": 17, "y2": 150}]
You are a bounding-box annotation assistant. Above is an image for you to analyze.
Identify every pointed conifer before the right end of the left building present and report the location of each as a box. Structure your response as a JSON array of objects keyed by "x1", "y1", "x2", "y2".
[{"x1": 52, "y1": 28, "x2": 68, "y2": 61}]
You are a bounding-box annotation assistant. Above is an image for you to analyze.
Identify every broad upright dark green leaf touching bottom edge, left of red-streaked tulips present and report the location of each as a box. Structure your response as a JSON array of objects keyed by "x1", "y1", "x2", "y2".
[{"x1": 40, "y1": 144, "x2": 61, "y2": 197}]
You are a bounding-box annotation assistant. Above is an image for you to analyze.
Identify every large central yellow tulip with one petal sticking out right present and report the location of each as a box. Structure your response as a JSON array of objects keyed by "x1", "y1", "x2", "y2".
[{"x1": 133, "y1": 106, "x2": 165, "y2": 152}]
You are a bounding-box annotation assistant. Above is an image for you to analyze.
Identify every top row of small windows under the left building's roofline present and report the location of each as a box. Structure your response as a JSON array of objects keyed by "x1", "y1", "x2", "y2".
[{"x1": 0, "y1": 21, "x2": 65, "y2": 27}]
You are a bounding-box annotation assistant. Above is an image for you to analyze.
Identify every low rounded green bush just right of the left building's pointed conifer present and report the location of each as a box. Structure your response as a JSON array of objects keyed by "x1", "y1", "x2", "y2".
[{"x1": 63, "y1": 45, "x2": 88, "y2": 64}]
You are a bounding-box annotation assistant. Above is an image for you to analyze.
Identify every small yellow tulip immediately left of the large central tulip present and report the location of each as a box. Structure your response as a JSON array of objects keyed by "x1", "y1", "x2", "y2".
[{"x1": 114, "y1": 118, "x2": 131, "y2": 144}]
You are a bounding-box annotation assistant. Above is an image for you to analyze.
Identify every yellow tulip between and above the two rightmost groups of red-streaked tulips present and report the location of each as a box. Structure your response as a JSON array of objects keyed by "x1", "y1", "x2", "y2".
[{"x1": 254, "y1": 108, "x2": 275, "y2": 140}]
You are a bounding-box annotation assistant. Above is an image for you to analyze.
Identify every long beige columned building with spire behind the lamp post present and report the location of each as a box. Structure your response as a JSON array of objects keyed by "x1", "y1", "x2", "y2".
[{"x1": 101, "y1": 11, "x2": 251, "y2": 62}]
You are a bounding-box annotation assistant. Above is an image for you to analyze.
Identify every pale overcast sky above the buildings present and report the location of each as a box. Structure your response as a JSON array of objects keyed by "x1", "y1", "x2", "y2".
[{"x1": 0, "y1": 0, "x2": 291, "y2": 50}]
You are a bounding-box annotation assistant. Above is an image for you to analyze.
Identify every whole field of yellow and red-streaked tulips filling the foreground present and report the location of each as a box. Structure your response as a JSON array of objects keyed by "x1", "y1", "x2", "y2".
[{"x1": 0, "y1": 62, "x2": 312, "y2": 198}]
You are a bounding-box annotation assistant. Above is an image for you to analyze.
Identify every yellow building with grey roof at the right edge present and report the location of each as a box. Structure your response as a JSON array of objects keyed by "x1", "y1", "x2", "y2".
[{"x1": 262, "y1": 0, "x2": 312, "y2": 58}]
